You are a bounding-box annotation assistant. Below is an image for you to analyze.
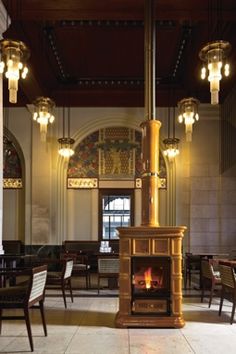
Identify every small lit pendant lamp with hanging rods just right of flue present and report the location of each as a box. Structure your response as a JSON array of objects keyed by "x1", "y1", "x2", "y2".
[{"x1": 163, "y1": 107, "x2": 180, "y2": 161}]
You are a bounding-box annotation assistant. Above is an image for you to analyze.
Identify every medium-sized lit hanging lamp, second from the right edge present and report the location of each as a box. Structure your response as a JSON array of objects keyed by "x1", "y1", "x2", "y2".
[{"x1": 178, "y1": 97, "x2": 199, "y2": 142}]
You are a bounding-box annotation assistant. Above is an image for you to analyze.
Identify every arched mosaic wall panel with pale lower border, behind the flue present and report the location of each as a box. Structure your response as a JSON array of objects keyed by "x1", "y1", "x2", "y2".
[{"x1": 67, "y1": 127, "x2": 166, "y2": 188}]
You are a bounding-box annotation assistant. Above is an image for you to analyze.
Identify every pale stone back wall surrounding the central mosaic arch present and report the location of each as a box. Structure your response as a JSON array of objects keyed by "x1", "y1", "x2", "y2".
[{"x1": 4, "y1": 105, "x2": 236, "y2": 252}]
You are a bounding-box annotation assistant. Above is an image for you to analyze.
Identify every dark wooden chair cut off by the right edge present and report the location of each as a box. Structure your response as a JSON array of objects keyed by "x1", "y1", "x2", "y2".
[{"x1": 219, "y1": 264, "x2": 236, "y2": 324}]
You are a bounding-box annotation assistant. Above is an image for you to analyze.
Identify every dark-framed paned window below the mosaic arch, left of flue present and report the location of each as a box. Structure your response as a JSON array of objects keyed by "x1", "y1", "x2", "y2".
[{"x1": 100, "y1": 190, "x2": 133, "y2": 240}]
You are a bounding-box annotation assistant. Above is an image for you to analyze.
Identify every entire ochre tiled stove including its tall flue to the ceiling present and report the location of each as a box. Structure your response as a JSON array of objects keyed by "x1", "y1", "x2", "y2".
[{"x1": 116, "y1": 0, "x2": 186, "y2": 328}]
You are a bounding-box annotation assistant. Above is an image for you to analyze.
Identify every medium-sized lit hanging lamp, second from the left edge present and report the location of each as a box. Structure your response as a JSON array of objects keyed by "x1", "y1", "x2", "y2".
[{"x1": 33, "y1": 97, "x2": 55, "y2": 141}]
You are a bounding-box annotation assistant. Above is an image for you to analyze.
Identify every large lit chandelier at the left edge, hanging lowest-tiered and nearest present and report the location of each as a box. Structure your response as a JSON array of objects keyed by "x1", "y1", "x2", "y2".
[{"x1": 0, "y1": 39, "x2": 30, "y2": 103}]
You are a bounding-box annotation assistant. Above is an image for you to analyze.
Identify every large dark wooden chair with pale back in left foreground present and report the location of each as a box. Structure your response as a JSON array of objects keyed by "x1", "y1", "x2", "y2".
[{"x1": 0, "y1": 265, "x2": 47, "y2": 351}]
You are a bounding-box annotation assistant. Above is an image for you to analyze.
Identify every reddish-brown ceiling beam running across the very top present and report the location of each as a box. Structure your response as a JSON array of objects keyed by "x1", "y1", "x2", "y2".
[{"x1": 3, "y1": 0, "x2": 236, "y2": 21}]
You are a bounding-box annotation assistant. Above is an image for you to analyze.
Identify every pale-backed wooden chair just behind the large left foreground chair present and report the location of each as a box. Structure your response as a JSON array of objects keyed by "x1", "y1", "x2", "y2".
[{"x1": 46, "y1": 259, "x2": 73, "y2": 308}]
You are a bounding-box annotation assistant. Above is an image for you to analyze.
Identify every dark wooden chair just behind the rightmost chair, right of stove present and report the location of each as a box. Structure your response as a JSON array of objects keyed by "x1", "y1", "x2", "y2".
[{"x1": 201, "y1": 259, "x2": 221, "y2": 307}]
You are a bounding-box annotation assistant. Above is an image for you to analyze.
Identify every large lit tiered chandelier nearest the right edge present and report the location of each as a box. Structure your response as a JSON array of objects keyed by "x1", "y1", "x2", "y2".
[{"x1": 199, "y1": 41, "x2": 231, "y2": 104}]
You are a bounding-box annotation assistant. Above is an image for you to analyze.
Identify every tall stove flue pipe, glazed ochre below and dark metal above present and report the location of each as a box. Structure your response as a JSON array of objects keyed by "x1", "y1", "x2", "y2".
[{"x1": 141, "y1": 0, "x2": 161, "y2": 226}]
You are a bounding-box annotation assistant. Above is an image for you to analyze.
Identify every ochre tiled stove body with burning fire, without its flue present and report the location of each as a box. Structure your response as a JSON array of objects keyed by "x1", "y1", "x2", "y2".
[{"x1": 116, "y1": 226, "x2": 185, "y2": 328}]
